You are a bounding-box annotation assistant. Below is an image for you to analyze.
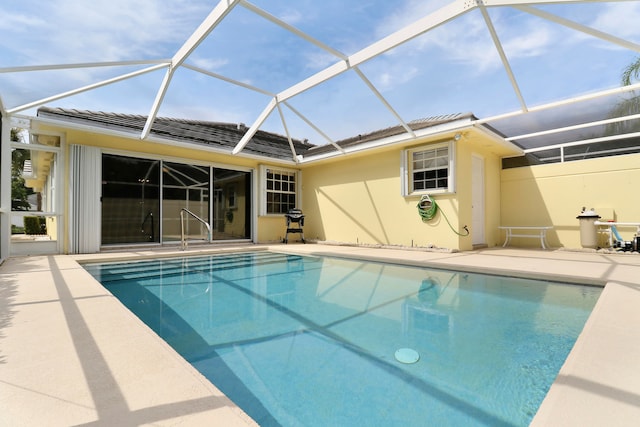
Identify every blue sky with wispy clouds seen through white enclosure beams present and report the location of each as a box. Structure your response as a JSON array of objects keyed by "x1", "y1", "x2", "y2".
[{"x1": 0, "y1": 0, "x2": 640, "y2": 144}]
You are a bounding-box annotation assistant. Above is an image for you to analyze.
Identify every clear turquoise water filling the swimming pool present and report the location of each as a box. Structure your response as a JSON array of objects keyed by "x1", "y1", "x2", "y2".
[{"x1": 85, "y1": 251, "x2": 601, "y2": 426}]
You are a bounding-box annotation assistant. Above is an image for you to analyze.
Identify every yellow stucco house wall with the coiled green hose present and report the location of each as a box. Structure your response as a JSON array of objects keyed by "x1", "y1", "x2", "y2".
[{"x1": 302, "y1": 134, "x2": 500, "y2": 250}]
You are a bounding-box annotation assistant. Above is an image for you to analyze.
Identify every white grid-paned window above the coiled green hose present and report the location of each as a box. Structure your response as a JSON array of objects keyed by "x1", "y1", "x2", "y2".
[{"x1": 402, "y1": 142, "x2": 455, "y2": 196}]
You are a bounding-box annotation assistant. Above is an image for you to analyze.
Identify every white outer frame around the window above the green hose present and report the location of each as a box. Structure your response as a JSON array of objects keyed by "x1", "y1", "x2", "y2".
[{"x1": 401, "y1": 141, "x2": 456, "y2": 197}]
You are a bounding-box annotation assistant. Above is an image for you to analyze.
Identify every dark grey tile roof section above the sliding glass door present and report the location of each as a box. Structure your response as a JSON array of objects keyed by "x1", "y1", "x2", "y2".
[{"x1": 38, "y1": 107, "x2": 313, "y2": 160}]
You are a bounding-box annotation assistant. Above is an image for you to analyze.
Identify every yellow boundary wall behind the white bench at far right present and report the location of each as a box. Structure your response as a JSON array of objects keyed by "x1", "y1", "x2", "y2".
[{"x1": 501, "y1": 154, "x2": 640, "y2": 248}]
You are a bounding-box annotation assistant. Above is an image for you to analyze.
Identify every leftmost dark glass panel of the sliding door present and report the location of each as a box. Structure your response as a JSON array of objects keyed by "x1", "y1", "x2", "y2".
[{"x1": 102, "y1": 154, "x2": 160, "y2": 245}]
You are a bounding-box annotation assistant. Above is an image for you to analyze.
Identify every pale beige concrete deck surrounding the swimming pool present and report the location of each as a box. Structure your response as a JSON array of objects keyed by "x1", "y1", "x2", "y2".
[{"x1": 0, "y1": 244, "x2": 640, "y2": 426}]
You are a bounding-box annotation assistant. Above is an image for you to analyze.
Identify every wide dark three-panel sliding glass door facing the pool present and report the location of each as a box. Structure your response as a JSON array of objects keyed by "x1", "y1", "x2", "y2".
[{"x1": 101, "y1": 154, "x2": 252, "y2": 245}]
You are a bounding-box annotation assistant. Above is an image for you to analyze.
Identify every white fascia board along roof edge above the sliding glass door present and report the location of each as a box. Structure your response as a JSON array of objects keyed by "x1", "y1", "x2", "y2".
[{"x1": 31, "y1": 117, "x2": 296, "y2": 166}]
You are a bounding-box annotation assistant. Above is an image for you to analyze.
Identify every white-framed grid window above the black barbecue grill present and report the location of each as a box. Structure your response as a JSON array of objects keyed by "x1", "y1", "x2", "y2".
[{"x1": 261, "y1": 167, "x2": 300, "y2": 215}]
